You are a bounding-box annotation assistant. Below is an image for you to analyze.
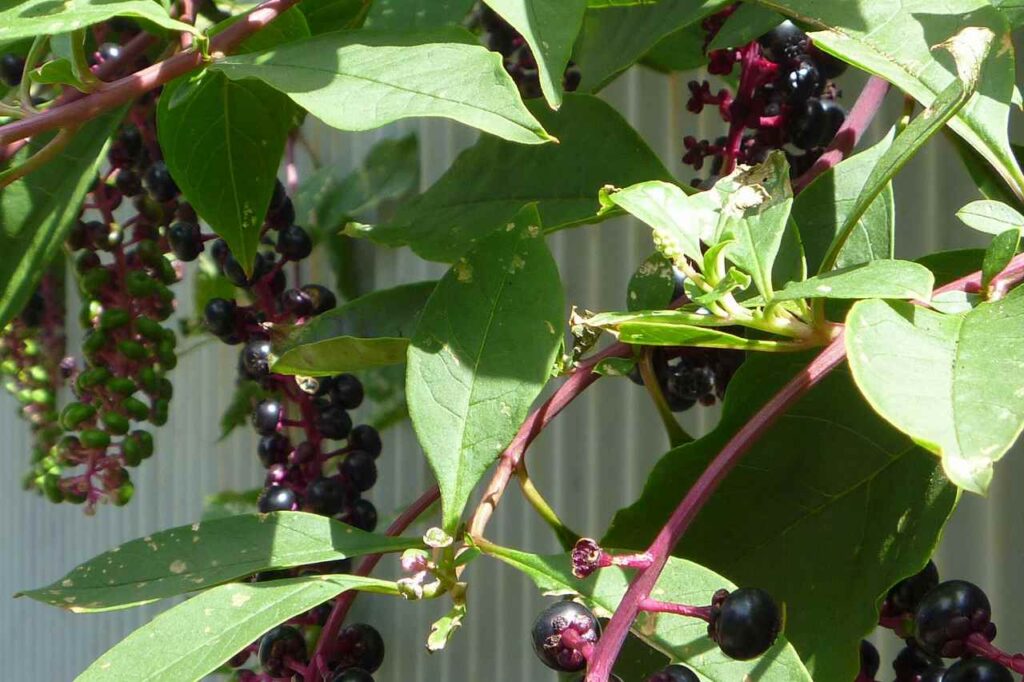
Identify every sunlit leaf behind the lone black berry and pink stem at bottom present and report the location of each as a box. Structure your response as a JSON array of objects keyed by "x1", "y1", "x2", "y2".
[{"x1": 480, "y1": 543, "x2": 811, "y2": 682}]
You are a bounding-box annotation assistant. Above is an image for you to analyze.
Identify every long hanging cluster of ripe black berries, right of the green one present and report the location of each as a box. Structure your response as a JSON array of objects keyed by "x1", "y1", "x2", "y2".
[{"x1": 199, "y1": 183, "x2": 384, "y2": 682}]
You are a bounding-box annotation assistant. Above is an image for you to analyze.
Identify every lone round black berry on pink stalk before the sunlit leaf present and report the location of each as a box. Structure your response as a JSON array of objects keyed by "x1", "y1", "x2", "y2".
[{"x1": 708, "y1": 588, "x2": 782, "y2": 660}]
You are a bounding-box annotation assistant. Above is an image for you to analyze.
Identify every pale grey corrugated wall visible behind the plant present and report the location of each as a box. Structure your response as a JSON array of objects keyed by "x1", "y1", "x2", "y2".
[{"x1": 0, "y1": 62, "x2": 1024, "y2": 682}]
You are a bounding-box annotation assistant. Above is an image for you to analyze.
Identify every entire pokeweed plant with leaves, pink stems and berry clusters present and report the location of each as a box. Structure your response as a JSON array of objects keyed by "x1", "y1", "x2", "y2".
[{"x1": 0, "y1": 0, "x2": 1024, "y2": 682}]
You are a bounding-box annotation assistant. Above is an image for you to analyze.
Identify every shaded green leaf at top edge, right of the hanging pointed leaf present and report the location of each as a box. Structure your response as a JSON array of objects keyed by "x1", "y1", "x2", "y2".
[{"x1": 572, "y1": 0, "x2": 728, "y2": 92}]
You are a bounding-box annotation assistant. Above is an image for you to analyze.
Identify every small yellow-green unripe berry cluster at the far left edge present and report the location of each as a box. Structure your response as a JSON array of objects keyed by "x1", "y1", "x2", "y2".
[{"x1": 0, "y1": 273, "x2": 65, "y2": 500}]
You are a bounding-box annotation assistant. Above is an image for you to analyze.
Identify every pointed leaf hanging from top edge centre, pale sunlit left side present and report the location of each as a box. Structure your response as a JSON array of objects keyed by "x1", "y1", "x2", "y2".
[{"x1": 486, "y1": 0, "x2": 587, "y2": 109}]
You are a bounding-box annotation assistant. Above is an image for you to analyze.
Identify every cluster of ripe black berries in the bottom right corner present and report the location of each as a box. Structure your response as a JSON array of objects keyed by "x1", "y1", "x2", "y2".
[{"x1": 858, "y1": 561, "x2": 1019, "y2": 682}]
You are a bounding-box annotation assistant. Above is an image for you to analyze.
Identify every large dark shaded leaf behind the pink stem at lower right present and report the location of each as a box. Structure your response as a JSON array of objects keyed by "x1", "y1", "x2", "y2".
[{"x1": 602, "y1": 354, "x2": 956, "y2": 680}]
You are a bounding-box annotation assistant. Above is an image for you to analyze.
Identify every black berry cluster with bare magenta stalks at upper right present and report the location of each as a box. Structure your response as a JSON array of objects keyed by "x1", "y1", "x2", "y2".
[{"x1": 683, "y1": 15, "x2": 846, "y2": 185}]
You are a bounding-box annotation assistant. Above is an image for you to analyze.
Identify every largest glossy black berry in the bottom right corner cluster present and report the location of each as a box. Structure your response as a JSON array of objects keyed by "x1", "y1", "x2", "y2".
[{"x1": 914, "y1": 581, "x2": 995, "y2": 657}]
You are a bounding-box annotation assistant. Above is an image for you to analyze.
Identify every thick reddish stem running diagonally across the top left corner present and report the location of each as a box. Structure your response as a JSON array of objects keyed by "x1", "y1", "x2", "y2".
[{"x1": 0, "y1": 0, "x2": 298, "y2": 145}]
